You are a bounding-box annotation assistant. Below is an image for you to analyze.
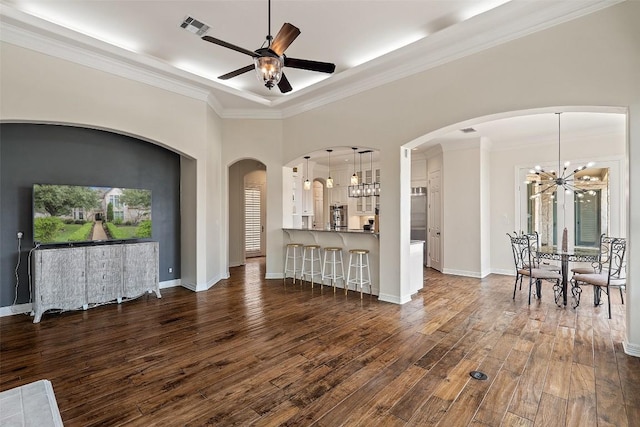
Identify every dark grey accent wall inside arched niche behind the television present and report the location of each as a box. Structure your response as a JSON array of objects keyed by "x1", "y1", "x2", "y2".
[{"x1": 0, "y1": 123, "x2": 180, "y2": 307}]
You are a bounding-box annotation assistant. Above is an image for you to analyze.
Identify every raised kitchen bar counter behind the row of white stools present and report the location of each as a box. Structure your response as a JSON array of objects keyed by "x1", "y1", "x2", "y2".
[{"x1": 282, "y1": 228, "x2": 380, "y2": 295}]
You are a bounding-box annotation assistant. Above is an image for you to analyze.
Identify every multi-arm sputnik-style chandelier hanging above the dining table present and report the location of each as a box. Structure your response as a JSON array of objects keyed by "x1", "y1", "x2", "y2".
[{"x1": 525, "y1": 113, "x2": 598, "y2": 199}]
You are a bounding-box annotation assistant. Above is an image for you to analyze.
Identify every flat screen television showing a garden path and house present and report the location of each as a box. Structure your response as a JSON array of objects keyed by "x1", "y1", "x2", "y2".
[{"x1": 33, "y1": 184, "x2": 151, "y2": 244}]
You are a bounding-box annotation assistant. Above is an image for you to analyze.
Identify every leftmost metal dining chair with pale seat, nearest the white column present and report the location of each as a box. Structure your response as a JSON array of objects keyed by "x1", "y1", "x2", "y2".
[{"x1": 507, "y1": 233, "x2": 562, "y2": 304}]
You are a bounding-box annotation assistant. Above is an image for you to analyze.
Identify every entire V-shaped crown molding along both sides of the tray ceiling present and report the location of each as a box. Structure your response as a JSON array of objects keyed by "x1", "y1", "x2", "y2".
[{"x1": 0, "y1": 0, "x2": 624, "y2": 119}]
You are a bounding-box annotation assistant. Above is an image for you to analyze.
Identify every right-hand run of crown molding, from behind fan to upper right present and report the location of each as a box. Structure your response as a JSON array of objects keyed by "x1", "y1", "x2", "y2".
[{"x1": 274, "y1": 0, "x2": 625, "y2": 118}]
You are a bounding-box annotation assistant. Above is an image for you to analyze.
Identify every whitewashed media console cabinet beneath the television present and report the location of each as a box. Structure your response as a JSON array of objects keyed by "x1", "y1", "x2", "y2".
[{"x1": 32, "y1": 242, "x2": 160, "y2": 323}]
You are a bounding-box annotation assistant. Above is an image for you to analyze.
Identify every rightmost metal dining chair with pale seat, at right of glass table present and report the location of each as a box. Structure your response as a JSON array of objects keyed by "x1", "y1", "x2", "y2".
[{"x1": 571, "y1": 238, "x2": 627, "y2": 319}]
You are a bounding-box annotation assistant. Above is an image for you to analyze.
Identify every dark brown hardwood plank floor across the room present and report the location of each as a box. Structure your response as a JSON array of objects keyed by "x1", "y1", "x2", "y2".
[{"x1": 0, "y1": 259, "x2": 640, "y2": 427}]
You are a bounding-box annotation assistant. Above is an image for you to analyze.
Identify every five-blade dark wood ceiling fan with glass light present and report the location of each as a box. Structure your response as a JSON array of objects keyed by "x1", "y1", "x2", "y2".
[{"x1": 202, "y1": 0, "x2": 336, "y2": 93}]
